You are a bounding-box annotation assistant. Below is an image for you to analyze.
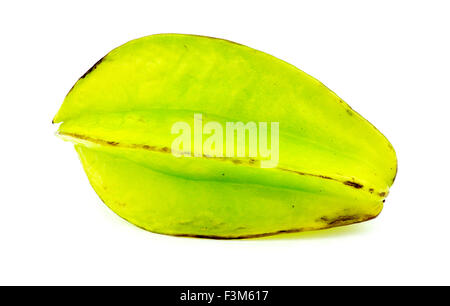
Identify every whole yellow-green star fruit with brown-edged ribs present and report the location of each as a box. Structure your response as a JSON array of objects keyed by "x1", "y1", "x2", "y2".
[{"x1": 54, "y1": 34, "x2": 397, "y2": 238}]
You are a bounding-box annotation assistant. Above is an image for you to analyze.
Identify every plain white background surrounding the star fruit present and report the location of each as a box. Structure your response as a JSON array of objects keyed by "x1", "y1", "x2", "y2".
[{"x1": 0, "y1": 0, "x2": 450, "y2": 285}]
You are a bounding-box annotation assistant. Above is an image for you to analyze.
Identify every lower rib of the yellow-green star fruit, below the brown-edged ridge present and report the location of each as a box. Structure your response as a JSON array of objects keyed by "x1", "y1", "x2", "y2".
[{"x1": 76, "y1": 145, "x2": 383, "y2": 239}]
